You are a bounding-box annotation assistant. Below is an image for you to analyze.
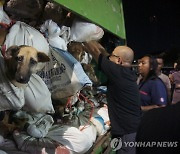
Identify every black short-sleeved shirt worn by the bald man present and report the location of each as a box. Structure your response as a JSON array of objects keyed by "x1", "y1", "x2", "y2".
[{"x1": 98, "y1": 55, "x2": 141, "y2": 136}]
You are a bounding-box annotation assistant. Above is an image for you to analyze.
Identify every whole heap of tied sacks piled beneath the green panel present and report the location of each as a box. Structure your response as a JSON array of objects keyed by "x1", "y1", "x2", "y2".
[{"x1": 0, "y1": 0, "x2": 109, "y2": 153}]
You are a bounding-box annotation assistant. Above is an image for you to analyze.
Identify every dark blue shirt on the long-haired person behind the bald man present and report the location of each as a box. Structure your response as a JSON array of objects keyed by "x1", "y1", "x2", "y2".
[{"x1": 139, "y1": 78, "x2": 168, "y2": 106}]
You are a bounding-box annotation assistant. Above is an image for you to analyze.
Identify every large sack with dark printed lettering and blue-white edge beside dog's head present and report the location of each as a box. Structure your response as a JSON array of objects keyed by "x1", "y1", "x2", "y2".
[{"x1": 38, "y1": 47, "x2": 92, "y2": 99}]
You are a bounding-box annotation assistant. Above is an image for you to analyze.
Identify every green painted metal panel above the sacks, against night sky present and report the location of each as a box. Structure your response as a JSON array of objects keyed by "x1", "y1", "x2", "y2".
[{"x1": 54, "y1": 0, "x2": 126, "y2": 39}]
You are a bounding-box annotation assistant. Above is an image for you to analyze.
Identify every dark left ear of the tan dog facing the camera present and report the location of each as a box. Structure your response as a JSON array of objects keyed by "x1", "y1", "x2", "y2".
[{"x1": 4, "y1": 45, "x2": 20, "y2": 59}]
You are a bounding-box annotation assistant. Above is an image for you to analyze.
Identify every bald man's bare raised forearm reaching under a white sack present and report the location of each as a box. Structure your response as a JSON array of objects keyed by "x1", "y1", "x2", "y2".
[{"x1": 83, "y1": 41, "x2": 109, "y2": 63}]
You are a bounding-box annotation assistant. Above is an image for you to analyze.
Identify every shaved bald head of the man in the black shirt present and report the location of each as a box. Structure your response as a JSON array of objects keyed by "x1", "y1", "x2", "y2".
[{"x1": 112, "y1": 46, "x2": 134, "y2": 65}]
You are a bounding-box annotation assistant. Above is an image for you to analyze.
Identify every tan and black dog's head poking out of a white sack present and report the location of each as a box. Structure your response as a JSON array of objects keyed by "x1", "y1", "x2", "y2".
[{"x1": 4, "y1": 45, "x2": 50, "y2": 84}]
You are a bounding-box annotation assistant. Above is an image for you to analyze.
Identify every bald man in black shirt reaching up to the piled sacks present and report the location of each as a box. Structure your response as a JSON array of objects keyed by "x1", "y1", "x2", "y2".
[{"x1": 84, "y1": 41, "x2": 141, "y2": 154}]
